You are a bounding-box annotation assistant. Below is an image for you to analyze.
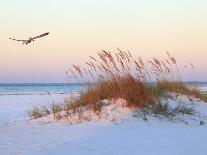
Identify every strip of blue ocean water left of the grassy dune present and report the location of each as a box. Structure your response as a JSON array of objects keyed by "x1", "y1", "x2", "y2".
[{"x1": 0, "y1": 83, "x2": 85, "y2": 96}]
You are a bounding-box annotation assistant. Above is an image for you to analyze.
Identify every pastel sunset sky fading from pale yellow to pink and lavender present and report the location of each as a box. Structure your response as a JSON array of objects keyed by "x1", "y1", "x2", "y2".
[{"x1": 0, "y1": 0, "x2": 207, "y2": 83}]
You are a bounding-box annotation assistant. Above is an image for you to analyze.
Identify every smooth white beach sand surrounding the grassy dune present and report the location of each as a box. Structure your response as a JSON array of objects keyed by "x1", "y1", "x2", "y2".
[{"x1": 0, "y1": 92, "x2": 207, "y2": 155}]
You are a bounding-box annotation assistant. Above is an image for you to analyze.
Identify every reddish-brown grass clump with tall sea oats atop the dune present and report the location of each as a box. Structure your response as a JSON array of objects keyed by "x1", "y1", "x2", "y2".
[{"x1": 28, "y1": 48, "x2": 207, "y2": 119}]
